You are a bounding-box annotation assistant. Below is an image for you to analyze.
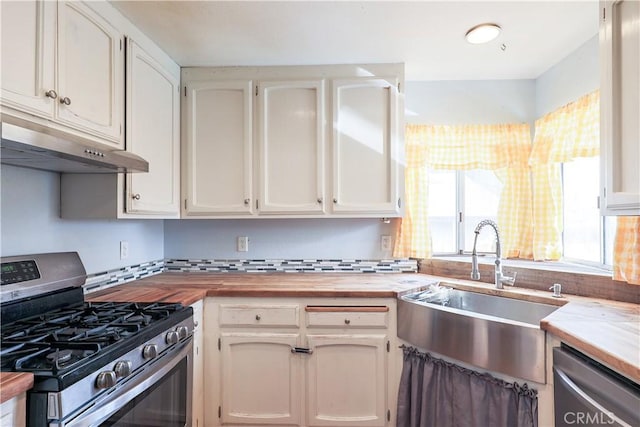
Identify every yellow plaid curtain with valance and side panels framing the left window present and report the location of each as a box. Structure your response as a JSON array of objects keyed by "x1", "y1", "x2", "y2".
[{"x1": 394, "y1": 124, "x2": 532, "y2": 258}]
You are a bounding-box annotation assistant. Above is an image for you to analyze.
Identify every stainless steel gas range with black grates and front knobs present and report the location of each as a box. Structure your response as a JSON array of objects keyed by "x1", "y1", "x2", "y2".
[{"x1": 0, "y1": 252, "x2": 193, "y2": 427}]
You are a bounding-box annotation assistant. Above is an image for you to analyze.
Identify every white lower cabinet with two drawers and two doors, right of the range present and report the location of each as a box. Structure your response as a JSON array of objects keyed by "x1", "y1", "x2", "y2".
[{"x1": 204, "y1": 298, "x2": 397, "y2": 427}]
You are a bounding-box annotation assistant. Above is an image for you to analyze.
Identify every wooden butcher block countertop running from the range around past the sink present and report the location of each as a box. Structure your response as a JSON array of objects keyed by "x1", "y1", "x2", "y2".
[{"x1": 87, "y1": 272, "x2": 640, "y2": 383}]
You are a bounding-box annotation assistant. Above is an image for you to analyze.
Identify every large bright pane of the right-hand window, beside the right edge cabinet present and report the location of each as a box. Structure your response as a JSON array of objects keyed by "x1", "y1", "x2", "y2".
[{"x1": 562, "y1": 157, "x2": 602, "y2": 263}]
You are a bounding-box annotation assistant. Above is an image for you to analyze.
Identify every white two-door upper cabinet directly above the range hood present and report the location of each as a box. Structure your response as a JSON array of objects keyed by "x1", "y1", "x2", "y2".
[{"x1": 1, "y1": 0, "x2": 124, "y2": 148}]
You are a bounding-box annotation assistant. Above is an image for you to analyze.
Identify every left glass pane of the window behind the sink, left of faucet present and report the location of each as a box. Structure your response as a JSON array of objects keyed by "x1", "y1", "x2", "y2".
[{"x1": 427, "y1": 170, "x2": 456, "y2": 254}]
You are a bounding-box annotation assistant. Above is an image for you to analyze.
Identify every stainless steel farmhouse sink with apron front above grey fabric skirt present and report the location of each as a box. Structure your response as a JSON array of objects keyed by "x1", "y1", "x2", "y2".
[{"x1": 398, "y1": 284, "x2": 559, "y2": 383}]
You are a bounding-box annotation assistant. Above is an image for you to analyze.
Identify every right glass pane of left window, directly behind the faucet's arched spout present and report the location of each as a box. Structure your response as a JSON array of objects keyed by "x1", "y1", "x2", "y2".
[{"x1": 464, "y1": 169, "x2": 502, "y2": 253}]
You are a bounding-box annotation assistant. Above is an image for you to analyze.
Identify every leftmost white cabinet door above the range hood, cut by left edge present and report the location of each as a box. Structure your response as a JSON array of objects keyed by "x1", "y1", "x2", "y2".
[{"x1": 0, "y1": 0, "x2": 57, "y2": 118}]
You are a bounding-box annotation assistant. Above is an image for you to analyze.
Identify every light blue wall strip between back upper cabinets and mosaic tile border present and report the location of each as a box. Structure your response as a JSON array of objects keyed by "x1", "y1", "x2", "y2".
[{"x1": 164, "y1": 219, "x2": 394, "y2": 259}]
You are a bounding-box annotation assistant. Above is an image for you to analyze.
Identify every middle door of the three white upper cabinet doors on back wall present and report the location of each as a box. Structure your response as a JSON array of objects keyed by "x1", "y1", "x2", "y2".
[{"x1": 258, "y1": 80, "x2": 325, "y2": 214}]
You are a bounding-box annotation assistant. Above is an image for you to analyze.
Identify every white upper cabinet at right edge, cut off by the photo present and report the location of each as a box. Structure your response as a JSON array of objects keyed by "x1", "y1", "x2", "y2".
[{"x1": 600, "y1": 0, "x2": 640, "y2": 215}]
